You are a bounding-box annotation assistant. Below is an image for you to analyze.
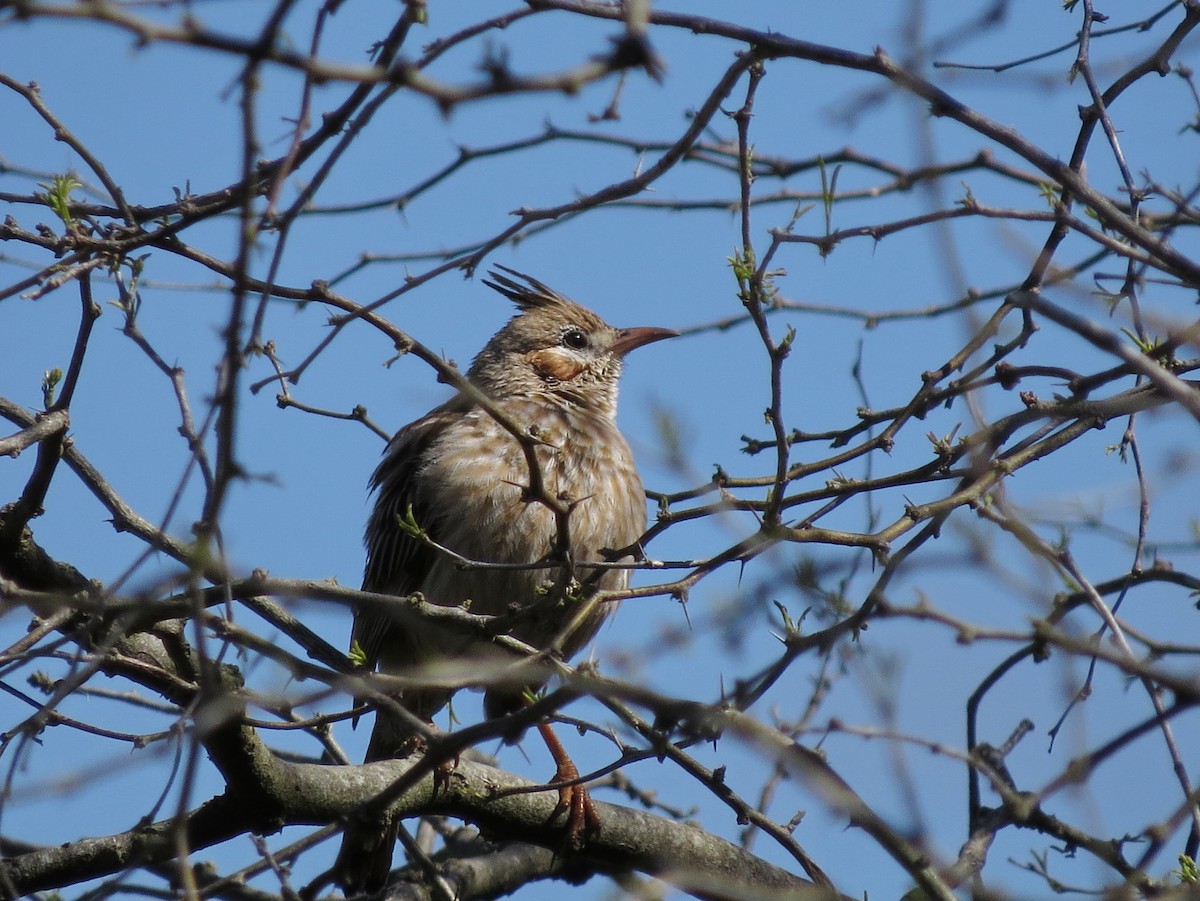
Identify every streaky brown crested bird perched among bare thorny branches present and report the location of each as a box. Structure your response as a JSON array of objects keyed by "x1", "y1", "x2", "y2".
[{"x1": 332, "y1": 265, "x2": 678, "y2": 895}]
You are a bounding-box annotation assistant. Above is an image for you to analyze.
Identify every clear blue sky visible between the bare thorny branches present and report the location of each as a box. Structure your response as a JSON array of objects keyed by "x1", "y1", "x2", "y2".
[{"x1": 0, "y1": 0, "x2": 1200, "y2": 897}]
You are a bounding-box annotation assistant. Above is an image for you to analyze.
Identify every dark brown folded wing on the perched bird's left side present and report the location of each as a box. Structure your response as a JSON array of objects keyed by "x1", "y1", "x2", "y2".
[{"x1": 350, "y1": 398, "x2": 464, "y2": 668}]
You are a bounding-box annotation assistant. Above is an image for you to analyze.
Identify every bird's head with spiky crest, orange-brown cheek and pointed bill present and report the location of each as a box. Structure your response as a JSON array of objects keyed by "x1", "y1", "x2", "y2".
[{"x1": 468, "y1": 266, "x2": 678, "y2": 416}]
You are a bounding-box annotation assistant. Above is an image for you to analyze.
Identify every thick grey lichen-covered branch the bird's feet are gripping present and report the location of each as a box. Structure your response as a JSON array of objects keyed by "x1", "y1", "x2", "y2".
[{"x1": 0, "y1": 756, "x2": 829, "y2": 899}]
